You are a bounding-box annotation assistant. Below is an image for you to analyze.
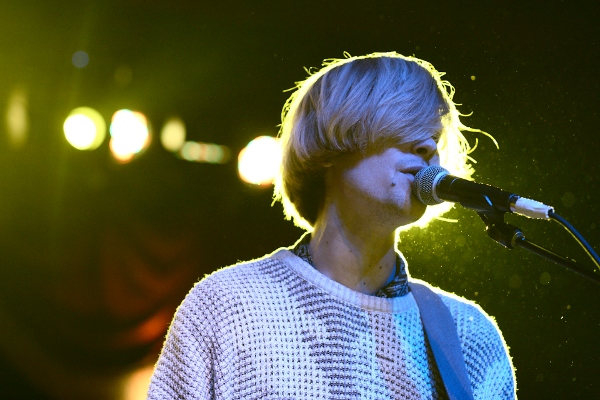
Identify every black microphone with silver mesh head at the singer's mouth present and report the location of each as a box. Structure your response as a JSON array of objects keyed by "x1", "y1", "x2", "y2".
[{"x1": 412, "y1": 165, "x2": 554, "y2": 219}]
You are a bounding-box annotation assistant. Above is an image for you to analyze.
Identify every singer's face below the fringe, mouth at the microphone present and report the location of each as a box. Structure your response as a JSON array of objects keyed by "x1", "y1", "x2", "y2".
[{"x1": 326, "y1": 138, "x2": 439, "y2": 229}]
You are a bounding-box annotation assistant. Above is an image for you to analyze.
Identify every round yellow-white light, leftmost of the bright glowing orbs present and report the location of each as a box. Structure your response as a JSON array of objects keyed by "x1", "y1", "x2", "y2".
[{"x1": 63, "y1": 107, "x2": 106, "y2": 150}]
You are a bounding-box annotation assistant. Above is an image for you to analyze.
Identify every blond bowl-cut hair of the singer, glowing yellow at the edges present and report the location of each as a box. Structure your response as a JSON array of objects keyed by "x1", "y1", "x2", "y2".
[{"x1": 274, "y1": 52, "x2": 490, "y2": 231}]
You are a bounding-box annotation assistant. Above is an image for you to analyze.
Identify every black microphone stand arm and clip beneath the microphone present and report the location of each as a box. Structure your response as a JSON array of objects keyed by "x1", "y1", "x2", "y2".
[{"x1": 477, "y1": 211, "x2": 600, "y2": 283}]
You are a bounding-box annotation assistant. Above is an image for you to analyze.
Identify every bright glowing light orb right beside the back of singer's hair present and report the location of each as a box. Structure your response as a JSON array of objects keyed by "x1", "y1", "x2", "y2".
[{"x1": 238, "y1": 136, "x2": 281, "y2": 185}]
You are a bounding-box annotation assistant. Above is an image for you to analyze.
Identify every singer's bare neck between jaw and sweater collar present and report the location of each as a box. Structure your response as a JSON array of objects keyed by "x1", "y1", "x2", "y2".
[{"x1": 309, "y1": 205, "x2": 396, "y2": 294}]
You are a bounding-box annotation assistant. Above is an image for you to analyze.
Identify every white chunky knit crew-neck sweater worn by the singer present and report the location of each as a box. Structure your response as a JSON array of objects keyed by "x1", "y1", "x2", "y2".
[{"x1": 148, "y1": 249, "x2": 516, "y2": 400}]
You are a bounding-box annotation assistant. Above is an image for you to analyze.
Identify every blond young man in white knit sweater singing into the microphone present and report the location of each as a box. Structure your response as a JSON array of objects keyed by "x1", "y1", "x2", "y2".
[{"x1": 149, "y1": 53, "x2": 516, "y2": 399}]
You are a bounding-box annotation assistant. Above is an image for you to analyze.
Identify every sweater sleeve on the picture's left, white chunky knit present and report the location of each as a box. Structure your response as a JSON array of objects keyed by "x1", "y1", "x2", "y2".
[{"x1": 148, "y1": 287, "x2": 214, "y2": 400}]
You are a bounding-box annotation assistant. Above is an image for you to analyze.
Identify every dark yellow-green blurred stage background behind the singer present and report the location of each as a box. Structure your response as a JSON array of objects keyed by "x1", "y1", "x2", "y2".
[{"x1": 0, "y1": 0, "x2": 600, "y2": 399}]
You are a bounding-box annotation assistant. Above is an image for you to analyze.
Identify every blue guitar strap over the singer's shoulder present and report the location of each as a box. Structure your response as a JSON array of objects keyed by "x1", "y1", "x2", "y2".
[{"x1": 409, "y1": 282, "x2": 473, "y2": 400}]
